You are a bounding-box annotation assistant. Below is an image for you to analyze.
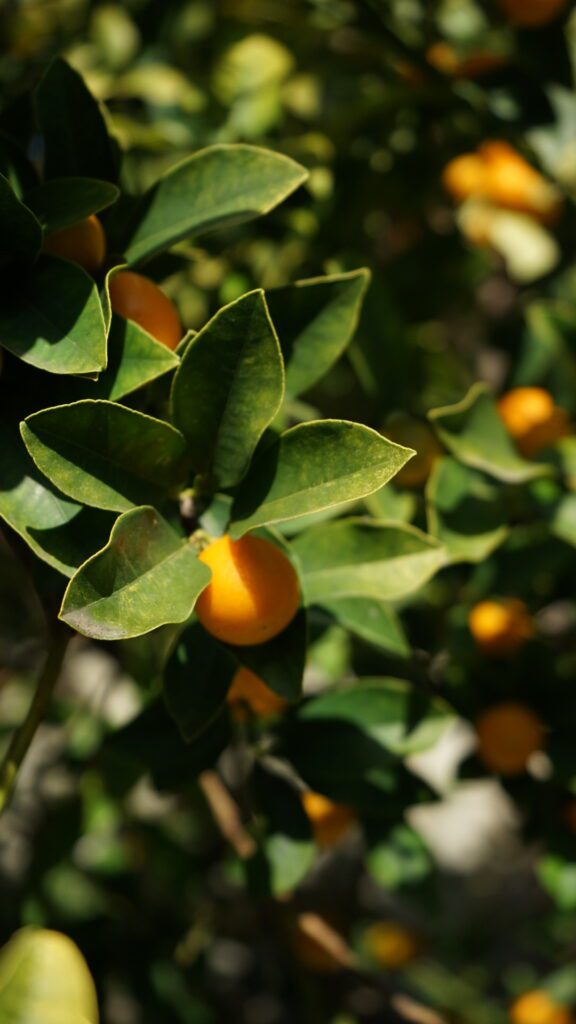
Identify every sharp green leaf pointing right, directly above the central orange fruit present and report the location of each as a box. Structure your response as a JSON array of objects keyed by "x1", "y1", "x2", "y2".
[{"x1": 231, "y1": 420, "x2": 413, "y2": 538}]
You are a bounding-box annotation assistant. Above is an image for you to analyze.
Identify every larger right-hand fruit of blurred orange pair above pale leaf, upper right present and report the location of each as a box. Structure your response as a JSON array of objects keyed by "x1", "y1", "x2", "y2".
[{"x1": 479, "y1": 140, "x2": 561, "y2": 220}]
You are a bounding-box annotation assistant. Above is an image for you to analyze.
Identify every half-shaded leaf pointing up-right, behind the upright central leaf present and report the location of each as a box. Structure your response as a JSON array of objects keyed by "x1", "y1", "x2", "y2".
[{"x1": 266, "y1": 268, "x2": 370, "y2": 397}]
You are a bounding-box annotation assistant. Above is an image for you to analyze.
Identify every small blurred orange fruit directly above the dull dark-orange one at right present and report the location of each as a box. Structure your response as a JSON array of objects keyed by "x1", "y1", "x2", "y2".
[{"x1": 468, "y1": 597, "x2": 534, "y2": 655}]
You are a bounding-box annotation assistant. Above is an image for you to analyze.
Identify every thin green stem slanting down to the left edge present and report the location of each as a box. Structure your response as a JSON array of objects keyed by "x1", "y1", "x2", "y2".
[{"x1": 0, "y1": 623, "x2": 73, "y2": 814}]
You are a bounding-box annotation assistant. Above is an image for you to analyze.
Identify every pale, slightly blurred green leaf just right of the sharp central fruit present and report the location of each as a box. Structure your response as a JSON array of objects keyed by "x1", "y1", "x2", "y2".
[{"x1": 292, "y1": 518, "x2": 446, "y2": 604}]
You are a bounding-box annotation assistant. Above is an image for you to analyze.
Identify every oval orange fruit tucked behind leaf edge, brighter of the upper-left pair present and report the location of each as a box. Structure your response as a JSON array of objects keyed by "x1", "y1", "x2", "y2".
[{"x1": 110, "y1": 270, "x2": 182, "y2": 349}]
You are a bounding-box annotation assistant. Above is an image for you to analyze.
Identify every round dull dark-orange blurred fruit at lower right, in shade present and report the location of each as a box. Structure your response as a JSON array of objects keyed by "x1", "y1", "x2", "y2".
[{"x1": 476, "y1": 700, "x2": 544, "y2": 775}]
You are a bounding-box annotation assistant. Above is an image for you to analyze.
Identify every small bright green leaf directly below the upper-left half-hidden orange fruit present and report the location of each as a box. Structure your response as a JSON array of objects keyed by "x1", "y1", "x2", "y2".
[{"x1": 82, "y1": 316, "x2": 179, "y2": 401}]
